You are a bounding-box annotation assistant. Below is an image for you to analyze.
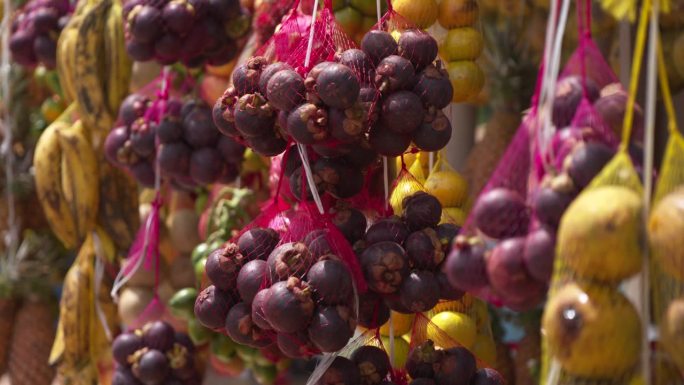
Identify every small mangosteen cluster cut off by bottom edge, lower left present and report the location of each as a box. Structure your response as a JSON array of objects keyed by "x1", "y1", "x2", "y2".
[{"x1": 112, "y1": 321, "x2": 202, "y2": 385}]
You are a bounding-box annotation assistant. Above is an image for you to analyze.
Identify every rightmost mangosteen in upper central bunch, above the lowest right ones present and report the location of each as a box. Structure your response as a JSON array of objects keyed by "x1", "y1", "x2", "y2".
[{"x1": 413, "y1": 62, "x2": 454, "y2": 110}]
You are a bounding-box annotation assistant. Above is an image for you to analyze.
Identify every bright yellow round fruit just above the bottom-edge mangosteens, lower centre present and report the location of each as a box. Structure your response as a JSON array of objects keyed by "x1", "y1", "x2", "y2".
[{"x1": 427, "y1": 311, "x2": 477, "y2": 349}]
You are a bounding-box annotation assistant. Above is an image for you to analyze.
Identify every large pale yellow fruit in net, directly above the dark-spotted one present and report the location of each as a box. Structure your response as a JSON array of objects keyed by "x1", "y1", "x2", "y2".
[{"x1": 557, "y1": 186, "x2": 644, "y2": 283}]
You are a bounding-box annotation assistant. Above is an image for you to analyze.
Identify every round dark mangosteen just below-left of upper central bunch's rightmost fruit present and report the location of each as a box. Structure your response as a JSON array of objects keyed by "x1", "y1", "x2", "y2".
[{"x1": 382, "y1": 91, "x2": 425, "y2": 134}]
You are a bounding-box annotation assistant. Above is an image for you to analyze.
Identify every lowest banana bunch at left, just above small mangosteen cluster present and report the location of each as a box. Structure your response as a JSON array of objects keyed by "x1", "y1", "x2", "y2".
[{"x1": 50, "y1": 228, "x2": 118, "y2": 385}]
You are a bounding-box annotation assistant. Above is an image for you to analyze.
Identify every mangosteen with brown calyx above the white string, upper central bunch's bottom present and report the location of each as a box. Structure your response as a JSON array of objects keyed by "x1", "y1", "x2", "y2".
[{"x1": 287, "y1": 103, "x2": 328, "y2": 144}]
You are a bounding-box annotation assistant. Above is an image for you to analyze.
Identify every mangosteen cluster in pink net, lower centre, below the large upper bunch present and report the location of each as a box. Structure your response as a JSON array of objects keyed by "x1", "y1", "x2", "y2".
[{"x1": 195, "y1": 228, "x2": 356, "y2": 358}]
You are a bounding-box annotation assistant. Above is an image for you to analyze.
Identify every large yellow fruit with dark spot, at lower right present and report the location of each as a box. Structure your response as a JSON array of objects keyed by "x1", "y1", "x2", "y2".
[{"x1": 542, "y1": 280, "x2": 641, "y2": 378}]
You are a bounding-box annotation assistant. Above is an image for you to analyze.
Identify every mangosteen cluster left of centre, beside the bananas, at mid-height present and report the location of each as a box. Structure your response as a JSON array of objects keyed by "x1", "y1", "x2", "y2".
[{"x1": 105, "y1": 94, "x2": 245, "y2": 189}]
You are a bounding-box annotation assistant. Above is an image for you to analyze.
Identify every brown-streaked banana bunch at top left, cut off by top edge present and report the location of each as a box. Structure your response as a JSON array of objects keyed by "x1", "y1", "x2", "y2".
[{"x1": 57, "y1": 0, "x2": 132, "y2": 144}]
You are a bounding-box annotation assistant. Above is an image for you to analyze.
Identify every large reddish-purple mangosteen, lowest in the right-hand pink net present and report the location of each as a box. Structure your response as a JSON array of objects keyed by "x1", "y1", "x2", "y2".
[{"x1": 487, "y1": 237, "x2": 545, "y2": 302}]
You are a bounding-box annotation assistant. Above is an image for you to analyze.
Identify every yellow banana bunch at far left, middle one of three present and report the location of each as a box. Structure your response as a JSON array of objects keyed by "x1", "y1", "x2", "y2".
[{"x1": 33, "y1": 105, "x2": 100, "y2": 249}]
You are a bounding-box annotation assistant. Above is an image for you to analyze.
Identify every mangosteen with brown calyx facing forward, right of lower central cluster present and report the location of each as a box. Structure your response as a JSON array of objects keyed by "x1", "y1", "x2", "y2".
[{"x1": 360, "y1": 241, "x2": 409, "y2": 294}]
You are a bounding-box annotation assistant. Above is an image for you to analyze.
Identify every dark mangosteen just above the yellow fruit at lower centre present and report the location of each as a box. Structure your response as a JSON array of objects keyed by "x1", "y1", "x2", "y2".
[{"x1": 399, "y1": 270, "x2": 440, "y2": 313}]
